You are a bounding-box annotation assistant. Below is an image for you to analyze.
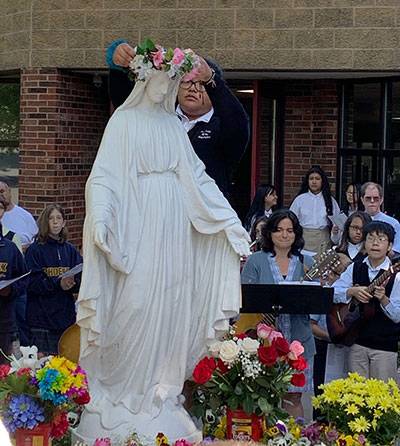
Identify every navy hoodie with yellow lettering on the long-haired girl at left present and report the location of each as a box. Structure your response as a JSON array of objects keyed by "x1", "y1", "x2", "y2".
[{"x1": 25, "y1": 238, "x2": 82, "y2": 331}]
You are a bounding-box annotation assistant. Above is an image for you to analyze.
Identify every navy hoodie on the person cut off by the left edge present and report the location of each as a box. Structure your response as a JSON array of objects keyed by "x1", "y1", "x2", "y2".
[{"x1": 0, "y1": 230, "x2": 27, "y2": 333}]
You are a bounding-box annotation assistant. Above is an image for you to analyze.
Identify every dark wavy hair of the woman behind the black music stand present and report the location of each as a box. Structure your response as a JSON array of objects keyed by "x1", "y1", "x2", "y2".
[{"x1": 261, "y1": 209, "x2": 304, "y2": 261}]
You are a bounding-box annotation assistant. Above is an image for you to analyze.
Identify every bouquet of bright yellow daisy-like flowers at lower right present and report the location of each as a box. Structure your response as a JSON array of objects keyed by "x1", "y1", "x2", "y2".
[{"x1": 313, "y1": 373, "x2": 400, "y2": 446}]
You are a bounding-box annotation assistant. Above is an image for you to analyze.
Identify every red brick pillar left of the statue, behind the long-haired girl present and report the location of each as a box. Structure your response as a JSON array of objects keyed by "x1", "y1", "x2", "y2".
[{"x1": 19, "y1": 69, "x2": 109, "y2": 245}]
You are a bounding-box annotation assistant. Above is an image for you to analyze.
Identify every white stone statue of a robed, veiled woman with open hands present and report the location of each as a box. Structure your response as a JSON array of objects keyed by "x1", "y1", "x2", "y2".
[{"x1": 77, "y1": 48, "x2": 248, "y2": 443}]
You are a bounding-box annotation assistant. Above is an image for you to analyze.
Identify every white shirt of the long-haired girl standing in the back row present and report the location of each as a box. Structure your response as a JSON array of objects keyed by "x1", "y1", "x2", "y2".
[{"x1": 290, "y1": 191, "x2": 340, "y2": 229}]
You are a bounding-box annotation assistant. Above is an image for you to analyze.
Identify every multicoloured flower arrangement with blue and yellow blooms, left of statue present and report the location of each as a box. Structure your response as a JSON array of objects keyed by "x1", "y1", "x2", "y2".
[{"x1": 0, "y1": 347, "x2": 90, "y2": 446}]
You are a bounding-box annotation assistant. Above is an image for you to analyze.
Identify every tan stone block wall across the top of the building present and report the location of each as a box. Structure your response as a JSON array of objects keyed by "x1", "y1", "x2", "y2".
[{"x1": 0, "y1": 0, "x2": 400, "y2": 70}]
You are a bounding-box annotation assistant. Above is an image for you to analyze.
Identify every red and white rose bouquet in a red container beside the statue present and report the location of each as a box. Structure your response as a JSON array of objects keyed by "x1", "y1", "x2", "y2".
[{"x1": 191, "y1": 324, "x2": 307, "y2": 440}]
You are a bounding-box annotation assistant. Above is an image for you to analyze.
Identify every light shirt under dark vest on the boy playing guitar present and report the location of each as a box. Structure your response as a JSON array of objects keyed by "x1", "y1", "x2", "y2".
[{"x1": 333, "y1": 257, "x2": 400, "y2": 323}]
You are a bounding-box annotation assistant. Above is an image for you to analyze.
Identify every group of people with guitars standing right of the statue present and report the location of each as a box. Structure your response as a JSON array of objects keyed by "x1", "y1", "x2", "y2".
[{"x1": 242, "y1": 171, "x2": 400, "y2": 417}]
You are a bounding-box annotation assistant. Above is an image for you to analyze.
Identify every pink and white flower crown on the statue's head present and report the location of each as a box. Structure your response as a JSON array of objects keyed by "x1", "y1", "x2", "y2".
[{"x1": 129, "y1": 39, "x2": 197, "y2": 81}]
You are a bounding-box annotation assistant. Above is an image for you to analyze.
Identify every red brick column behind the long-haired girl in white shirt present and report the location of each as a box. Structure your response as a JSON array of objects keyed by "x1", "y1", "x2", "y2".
[{"x1": 284, "y1": 80, "x2": 339, "y2": 205}]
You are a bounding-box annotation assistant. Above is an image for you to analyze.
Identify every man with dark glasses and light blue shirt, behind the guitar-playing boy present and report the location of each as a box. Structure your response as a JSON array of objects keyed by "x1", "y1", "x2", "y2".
[{"x1": 361, "y1": 182, "x2": 400, "y2": 254}]
